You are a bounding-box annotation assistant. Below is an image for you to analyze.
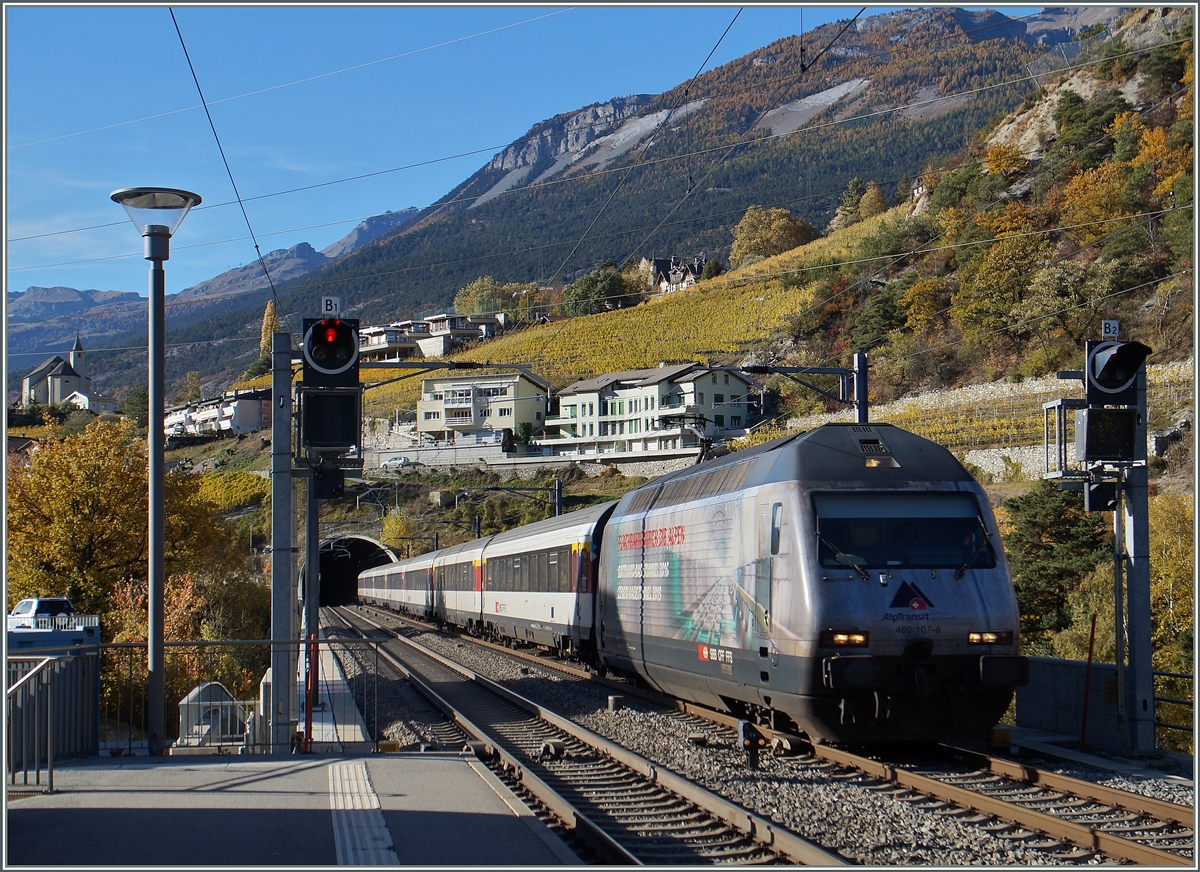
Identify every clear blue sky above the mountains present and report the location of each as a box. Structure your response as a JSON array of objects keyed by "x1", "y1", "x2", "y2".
[{"x1": 5, "y1": 4, "x2": 1034, "y2": 294}]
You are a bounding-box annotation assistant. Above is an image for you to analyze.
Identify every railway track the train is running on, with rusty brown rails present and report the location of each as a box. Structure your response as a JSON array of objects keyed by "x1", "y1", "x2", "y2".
[{"x1": 348, "y1": 613, "x2": 1195, "y2": 866}]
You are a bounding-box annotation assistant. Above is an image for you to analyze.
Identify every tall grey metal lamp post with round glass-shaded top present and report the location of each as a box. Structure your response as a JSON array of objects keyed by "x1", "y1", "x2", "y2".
[{"x1": 112, "y1": 188, "x2": 200, "y2": 754}]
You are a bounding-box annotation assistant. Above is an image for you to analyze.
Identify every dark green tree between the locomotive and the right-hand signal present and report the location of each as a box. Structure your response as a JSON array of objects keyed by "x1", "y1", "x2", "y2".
[{"x1": 1004, "y1": 480, "x2": 1109, "y2": 647}]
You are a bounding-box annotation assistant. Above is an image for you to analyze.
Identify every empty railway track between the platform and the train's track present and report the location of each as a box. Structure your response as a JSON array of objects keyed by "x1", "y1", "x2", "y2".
[{"x1": 328, "y1": 613, "x2": 846, "y2": 866}]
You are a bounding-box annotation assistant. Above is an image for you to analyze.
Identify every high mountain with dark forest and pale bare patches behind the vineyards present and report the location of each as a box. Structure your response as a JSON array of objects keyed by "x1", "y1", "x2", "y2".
[{"x1": 93, "y1": 10, "x2": 1094, "y2": 393}]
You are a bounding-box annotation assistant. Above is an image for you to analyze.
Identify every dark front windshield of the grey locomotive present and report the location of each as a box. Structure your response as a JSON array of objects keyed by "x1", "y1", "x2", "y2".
[{"x1": 812, "y1": 493, "x2": 996, "y2": 575}]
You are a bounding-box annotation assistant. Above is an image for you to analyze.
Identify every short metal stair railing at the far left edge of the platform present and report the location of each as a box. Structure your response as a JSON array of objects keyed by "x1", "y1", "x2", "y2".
[{"x1": 5, "y1": 657, "x2": 58, "y2": 792}]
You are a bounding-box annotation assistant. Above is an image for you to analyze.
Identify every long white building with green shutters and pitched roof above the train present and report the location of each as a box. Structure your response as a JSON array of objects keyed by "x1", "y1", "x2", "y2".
[{"x1": 539, "y1": 363, "x2": 762, "y2": 455}]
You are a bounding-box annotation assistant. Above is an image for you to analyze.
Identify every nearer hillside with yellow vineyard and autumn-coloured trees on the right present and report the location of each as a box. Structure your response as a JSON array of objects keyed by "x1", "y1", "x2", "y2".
[{"x1": 352, "y1": 9, "x2": 1194, "y2": 427}]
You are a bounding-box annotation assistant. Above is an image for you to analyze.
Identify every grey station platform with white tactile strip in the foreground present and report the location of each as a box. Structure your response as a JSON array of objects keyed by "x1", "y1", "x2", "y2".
[{"x1": 5, "y1": 752, "x2": 580, "y2": 868}]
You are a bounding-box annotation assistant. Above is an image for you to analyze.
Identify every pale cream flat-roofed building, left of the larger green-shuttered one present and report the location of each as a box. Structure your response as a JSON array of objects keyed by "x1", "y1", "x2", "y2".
[{"x1": 416, "y1": 369, "x2": 550, "y2": 445}]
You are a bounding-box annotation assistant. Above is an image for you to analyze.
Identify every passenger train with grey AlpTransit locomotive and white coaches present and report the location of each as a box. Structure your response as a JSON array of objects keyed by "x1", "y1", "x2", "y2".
[{"x1": 359, "y1": 423, "x2": 1028, "y2": 744}]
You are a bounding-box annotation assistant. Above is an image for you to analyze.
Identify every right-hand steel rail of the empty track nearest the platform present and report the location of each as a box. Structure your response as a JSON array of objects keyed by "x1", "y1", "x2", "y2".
[{"x1": 343, "y1": 606, "x2": 847, "y2": 866}]
